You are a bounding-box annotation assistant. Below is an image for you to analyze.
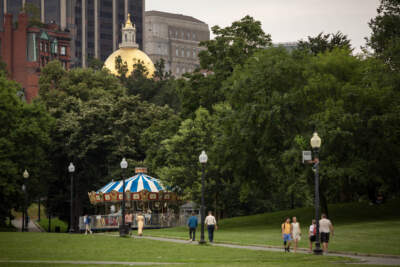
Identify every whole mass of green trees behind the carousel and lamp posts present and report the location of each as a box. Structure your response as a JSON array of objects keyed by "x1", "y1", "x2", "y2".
[{"x1": 0, "y1": 0, "x2": 400, "y2": 227}]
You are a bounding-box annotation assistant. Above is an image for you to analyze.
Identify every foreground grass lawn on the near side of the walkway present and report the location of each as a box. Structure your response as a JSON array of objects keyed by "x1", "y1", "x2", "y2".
[{"x1": 0, "y1": 232, "x2": 372, "y2": 267}]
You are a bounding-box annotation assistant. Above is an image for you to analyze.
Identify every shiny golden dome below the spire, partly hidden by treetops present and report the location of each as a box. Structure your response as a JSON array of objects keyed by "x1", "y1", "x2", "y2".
[{"x1": 104, "y1": 47, "x2": 155, "y2": 78}]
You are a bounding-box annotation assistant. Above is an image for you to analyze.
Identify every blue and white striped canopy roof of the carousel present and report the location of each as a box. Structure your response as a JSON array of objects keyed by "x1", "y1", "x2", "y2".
[{"x1": 96, "y1": 173, "x2": 165, "y2": 193}]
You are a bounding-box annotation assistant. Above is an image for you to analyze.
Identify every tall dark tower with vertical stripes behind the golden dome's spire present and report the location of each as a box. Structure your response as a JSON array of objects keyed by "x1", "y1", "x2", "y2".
[{"x1": 0, "y1": 0, "x2": 145, "y2": 67}]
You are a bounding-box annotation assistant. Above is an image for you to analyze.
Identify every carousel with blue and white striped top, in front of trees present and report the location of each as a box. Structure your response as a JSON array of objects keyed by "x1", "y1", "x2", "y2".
[{"x1": 79, "y1": 167, "x2": 180, "y2": 230}]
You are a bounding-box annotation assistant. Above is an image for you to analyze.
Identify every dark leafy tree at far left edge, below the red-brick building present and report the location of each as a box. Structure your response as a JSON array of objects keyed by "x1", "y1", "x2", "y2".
[{"x1": 0, "y1": 72, "x2": 53, "y2": 226}]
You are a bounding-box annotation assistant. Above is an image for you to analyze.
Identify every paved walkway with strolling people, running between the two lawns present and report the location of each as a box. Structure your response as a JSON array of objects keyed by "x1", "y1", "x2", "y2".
[{"x1": 128, "y1": 236, "x2": 400, "y2": 266}]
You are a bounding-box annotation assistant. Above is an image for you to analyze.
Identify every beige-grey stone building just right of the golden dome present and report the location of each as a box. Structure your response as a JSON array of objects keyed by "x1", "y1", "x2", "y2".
[{"x1": 144, "y1": 11, "x2": 210, "y2": 77}]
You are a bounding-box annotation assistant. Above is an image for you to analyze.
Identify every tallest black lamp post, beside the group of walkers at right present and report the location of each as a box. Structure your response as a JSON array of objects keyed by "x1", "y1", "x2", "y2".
[{"x1": 310, "y1": 132, "x2": 322, "y2": 255}]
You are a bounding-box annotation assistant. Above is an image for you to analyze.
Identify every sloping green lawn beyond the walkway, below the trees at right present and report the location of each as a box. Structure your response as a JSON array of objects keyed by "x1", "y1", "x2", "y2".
[{"x1": 145, "y1": 200, "x2": 400, "y2": 255}]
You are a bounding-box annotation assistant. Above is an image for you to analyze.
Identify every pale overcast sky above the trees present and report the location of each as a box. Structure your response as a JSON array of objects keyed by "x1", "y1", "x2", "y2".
[{"x1": 146, "y1": 0, "x2": 379, "y2": 51}]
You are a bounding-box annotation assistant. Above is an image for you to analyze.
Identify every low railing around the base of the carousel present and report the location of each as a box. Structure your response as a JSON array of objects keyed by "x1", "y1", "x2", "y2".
[{"x1": 79, "y1": 213, "x2": 196, "y2": 231}]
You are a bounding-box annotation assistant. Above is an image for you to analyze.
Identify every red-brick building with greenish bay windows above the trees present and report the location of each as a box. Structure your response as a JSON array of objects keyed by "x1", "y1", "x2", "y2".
[{"x1": 0, "y1": 13, "x2": 71, "y2": 102}]
